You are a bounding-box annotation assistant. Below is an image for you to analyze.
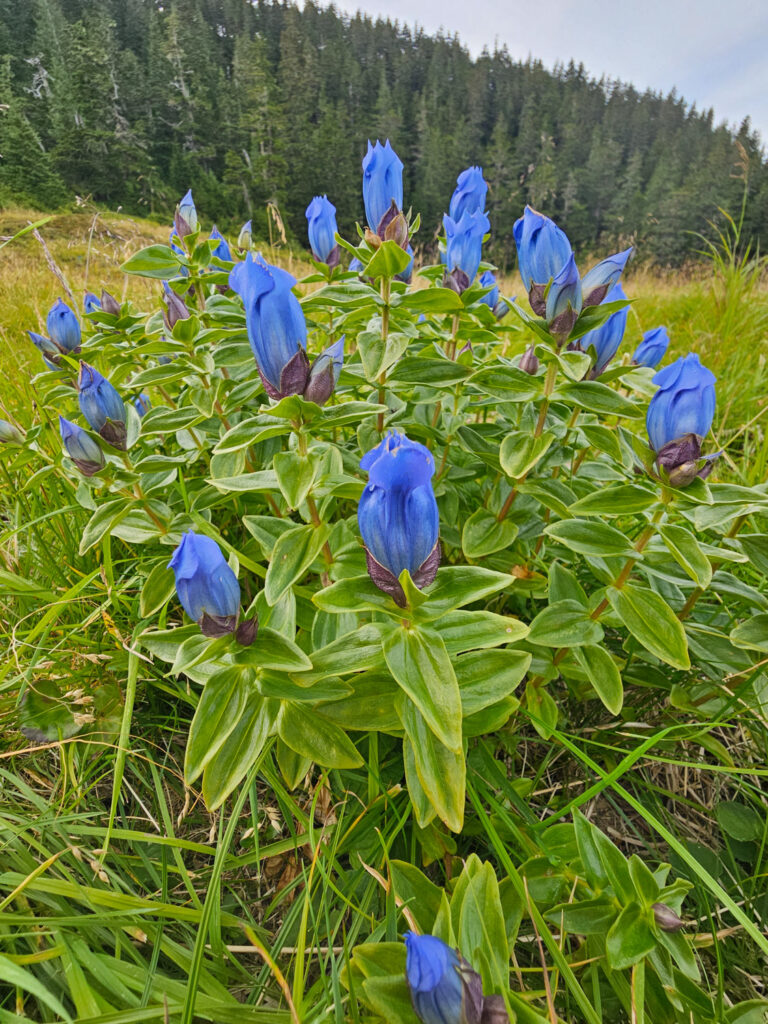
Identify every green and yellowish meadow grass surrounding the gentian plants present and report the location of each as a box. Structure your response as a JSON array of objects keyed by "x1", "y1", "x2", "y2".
[{"x1": 0, "y1": 203, "x2": 768, "y2": 1024}]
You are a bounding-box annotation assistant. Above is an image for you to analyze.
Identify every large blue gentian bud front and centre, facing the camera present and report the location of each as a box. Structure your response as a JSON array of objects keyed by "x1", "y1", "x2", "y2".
[{"x1": 357, "y1": 431, "x2": 440, "y2": 607}]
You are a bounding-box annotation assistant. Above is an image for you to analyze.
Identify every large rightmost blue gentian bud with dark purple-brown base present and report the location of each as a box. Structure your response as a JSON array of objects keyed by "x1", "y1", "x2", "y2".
[{"x1": 646, "y1": 352, "x2": 717, "y2": 486}]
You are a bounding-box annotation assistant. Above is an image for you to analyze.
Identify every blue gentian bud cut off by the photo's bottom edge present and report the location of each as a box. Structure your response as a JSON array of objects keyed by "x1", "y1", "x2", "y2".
[{"x1": 406, "y1": 932, "x2": 483, "y2": 1024}]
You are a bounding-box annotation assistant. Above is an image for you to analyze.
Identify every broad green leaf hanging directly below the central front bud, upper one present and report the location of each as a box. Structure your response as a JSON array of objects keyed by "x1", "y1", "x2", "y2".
[{"x1": 383, "y1": 628, "x2": 462, "y2": 754}]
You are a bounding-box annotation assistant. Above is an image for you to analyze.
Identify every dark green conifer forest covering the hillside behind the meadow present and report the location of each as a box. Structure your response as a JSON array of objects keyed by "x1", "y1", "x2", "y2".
[{"x1": 0, "y1": 0, "x2": 768, "y2": 267}]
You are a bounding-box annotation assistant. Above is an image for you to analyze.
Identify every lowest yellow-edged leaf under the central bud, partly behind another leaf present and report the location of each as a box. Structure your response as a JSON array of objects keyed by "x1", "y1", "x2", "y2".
[{"x1": 395, "y1": 693, "x2": 467, "y2": 833}]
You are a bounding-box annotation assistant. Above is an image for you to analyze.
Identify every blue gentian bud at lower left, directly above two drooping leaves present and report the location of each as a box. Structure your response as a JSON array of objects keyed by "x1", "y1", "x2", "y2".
[{"x1": 168, "y1": 530, "x2": 240, "y2": 637}]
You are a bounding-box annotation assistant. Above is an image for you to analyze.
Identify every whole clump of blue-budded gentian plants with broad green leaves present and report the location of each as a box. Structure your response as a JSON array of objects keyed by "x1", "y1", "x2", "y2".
[{"x1": 9, "y1": 140, "x2": 768, "y2": 1024}]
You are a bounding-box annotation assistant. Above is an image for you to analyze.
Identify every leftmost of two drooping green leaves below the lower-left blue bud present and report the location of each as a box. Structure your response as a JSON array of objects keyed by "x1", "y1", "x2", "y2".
[{"x1": 184, "y1": 669, "x2": 249, "y2": 785}]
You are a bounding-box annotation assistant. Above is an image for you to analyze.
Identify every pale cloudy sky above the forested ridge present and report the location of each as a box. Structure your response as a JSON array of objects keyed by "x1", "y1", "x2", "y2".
[{"x1": 322, "y1": 0, "x2": 768, "y2": 142}]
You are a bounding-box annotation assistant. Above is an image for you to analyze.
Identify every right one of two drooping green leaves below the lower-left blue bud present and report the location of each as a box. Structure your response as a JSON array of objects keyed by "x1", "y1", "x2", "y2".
[{"x1": 203, "y1": 692, "x2": 278, "y2": 811}]
